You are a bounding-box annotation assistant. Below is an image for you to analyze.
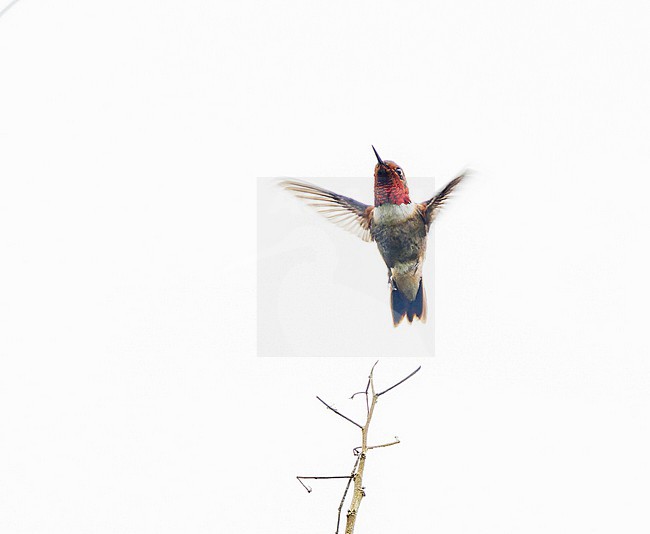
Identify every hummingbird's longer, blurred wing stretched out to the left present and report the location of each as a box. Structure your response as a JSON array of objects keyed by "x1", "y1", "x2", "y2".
[{"x1": 280, "y1": 180, "x2": 372, "y2": 245}]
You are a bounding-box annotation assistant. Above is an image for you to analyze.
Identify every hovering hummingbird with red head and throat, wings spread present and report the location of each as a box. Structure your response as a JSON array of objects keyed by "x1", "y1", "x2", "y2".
[{"x1": 280, "y1": 146, "x2": 467, "y2": 326}]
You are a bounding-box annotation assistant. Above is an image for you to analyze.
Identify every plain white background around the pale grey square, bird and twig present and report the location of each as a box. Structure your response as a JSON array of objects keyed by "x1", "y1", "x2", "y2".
[{"x1": 0, "y1": 0, "x2": 650, "y2": 534}]
